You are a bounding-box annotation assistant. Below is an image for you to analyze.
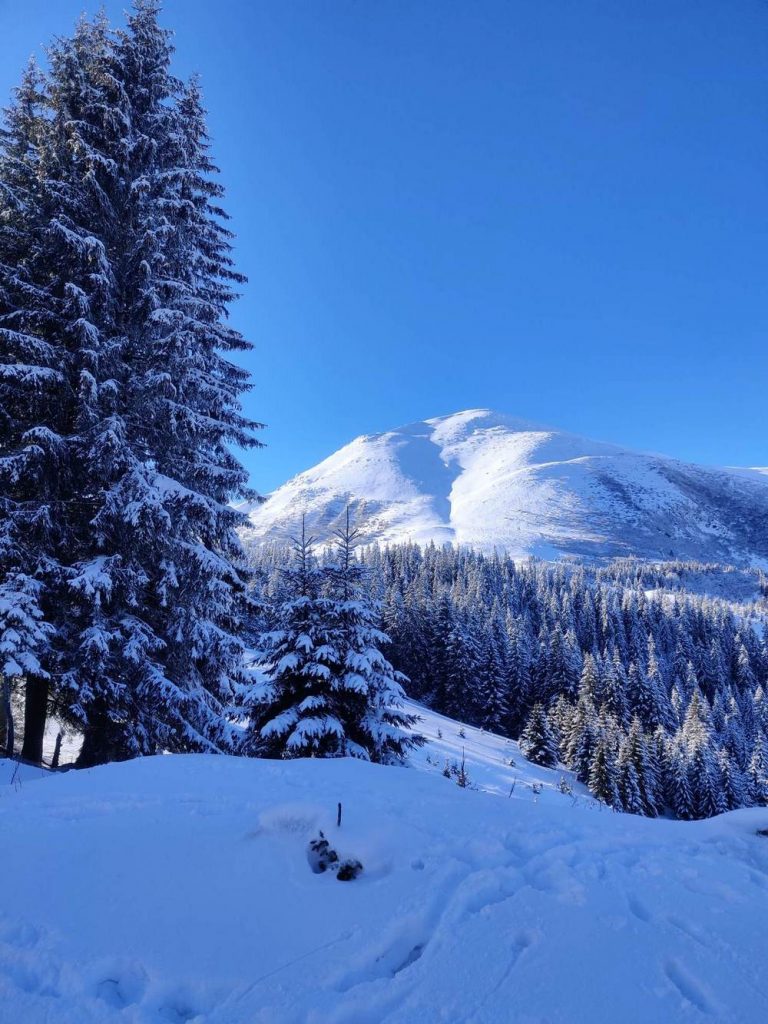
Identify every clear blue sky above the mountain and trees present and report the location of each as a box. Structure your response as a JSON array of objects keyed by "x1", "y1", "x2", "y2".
[{"x1": 0, "y1": 0, "x2": 768, "y2": 490}]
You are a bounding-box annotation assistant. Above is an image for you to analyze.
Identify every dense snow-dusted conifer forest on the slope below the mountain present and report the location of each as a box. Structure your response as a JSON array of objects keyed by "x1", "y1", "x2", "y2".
[{"x1": 252, "y1": 545, "x2": 768, "y2": 818}]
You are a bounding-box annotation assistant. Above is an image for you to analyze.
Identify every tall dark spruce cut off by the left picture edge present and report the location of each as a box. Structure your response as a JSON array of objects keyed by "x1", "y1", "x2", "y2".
[{"x1": 0, "y1": 58, "x2": 69, "y2": 761}]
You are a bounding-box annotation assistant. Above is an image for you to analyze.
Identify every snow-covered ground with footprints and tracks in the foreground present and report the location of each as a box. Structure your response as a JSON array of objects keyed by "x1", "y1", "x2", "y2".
[{"x1": 0, "y1": 713, "x2": 768, "y2": 1024}]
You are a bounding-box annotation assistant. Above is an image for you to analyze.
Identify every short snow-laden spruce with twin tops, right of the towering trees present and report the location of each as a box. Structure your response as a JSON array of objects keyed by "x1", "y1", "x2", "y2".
[{"x1": 245, "y1": 514, "x2": 419, "y2": 764}]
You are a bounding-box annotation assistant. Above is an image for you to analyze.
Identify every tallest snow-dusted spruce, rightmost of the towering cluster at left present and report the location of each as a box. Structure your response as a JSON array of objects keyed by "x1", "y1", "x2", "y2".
[{"x1": 72, "y1": 6, "x2": 257, "y2": 763}]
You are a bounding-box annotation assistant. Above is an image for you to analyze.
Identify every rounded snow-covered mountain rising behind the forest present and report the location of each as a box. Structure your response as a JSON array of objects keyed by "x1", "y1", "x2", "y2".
[{"x1": 248, "y1": 409, "x2": 768, "y2": 564}]
